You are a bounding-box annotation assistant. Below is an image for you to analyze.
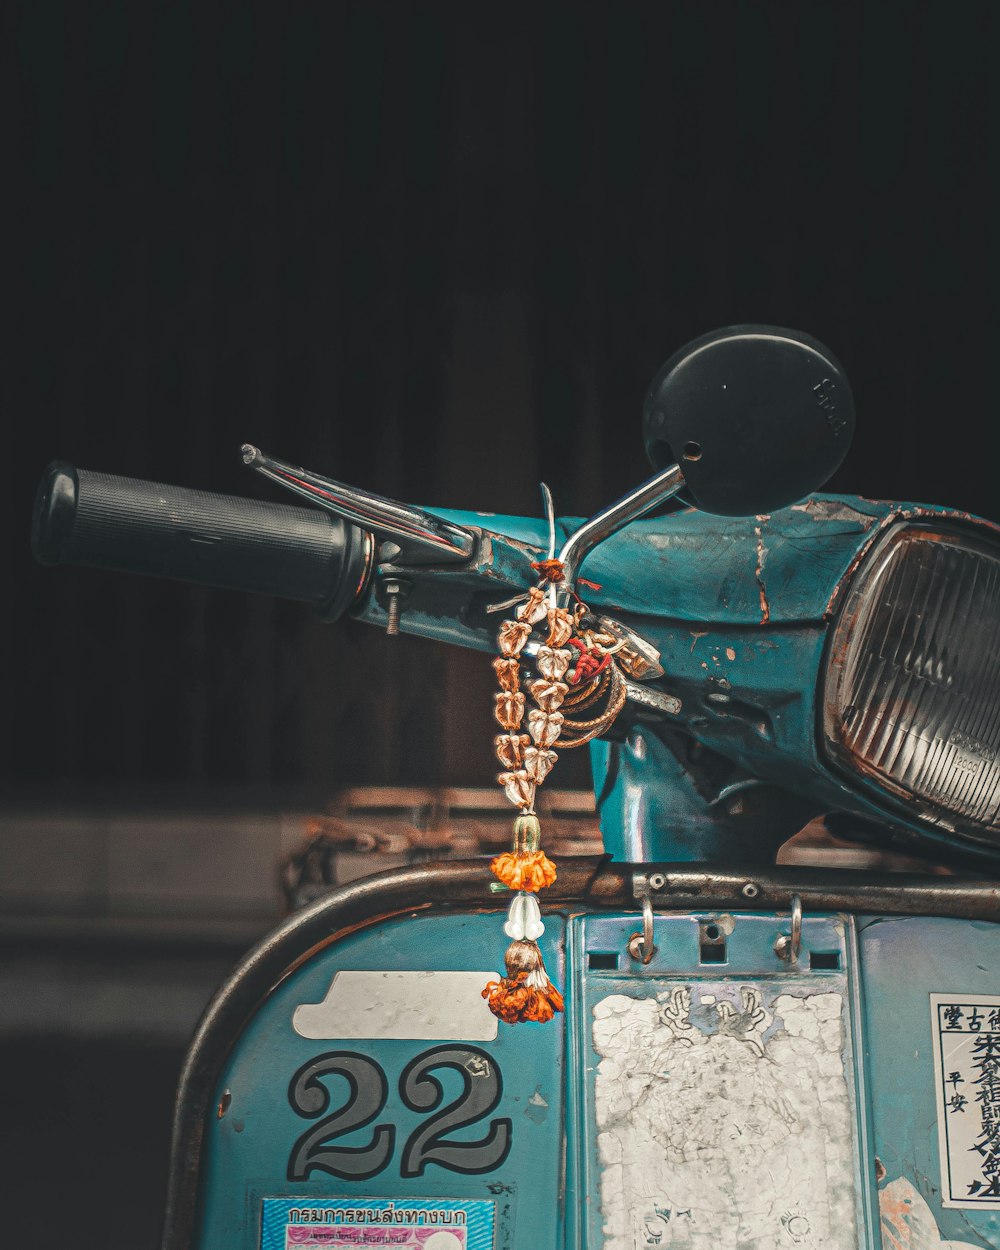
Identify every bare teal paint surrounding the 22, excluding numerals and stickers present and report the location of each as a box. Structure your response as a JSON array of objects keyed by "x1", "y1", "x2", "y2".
[{"x1": 196, "y1": 915, "x2": 565, "y2": 1250}]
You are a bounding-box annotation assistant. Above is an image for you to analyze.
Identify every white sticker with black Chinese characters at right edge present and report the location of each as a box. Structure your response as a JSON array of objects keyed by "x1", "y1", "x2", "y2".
[{"x1": 930, "y1": 994, "x2": 1000, "y2": 1211}]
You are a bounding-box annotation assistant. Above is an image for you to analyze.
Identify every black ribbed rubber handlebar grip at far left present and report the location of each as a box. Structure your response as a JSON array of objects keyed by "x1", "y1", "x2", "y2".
[{"x1": 31, "y1": 460, "x2": 366, "y2": 620}]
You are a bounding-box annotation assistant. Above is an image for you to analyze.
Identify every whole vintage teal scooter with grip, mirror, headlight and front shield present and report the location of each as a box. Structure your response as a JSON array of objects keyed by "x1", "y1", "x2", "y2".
[{"x1": 34, "y1": 326, "x2": 1000, "y2": 1250}]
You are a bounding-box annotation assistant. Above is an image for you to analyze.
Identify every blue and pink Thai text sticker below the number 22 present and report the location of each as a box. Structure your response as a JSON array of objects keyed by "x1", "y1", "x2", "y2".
[{"x1": 260, "y1": 1198, "x2": 495, "y2": 1250}]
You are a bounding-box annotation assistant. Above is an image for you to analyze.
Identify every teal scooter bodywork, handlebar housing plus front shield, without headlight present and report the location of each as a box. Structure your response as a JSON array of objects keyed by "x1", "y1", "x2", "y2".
[{"x1": 160, "y1": 496, "x2": 1000, "y2": 1250}]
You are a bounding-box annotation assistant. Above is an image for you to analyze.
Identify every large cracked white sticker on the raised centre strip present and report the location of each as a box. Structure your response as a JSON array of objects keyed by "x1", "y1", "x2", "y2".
[{"x1": 594, "y1": 983, "x2": 858, "y2": 1250}]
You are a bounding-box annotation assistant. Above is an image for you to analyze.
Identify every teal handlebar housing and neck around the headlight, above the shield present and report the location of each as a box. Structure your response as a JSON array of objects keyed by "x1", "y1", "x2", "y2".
[{"x1": 358, "y1": 495, "x2": 1000, "y2": 863}]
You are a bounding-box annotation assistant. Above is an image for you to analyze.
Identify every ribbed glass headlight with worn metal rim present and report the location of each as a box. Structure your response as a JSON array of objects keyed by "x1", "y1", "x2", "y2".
[{"x1": 824, "y1": 524, "x2": 1000, "y2": 841}]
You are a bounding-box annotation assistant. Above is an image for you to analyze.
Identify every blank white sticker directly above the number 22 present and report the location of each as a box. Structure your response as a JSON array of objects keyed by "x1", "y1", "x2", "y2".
[{"x1": 291, "y1": 971, "x2": 498, "y2": 1041}]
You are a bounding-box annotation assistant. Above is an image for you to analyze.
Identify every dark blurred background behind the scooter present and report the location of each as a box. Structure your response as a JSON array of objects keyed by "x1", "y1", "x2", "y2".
[{"x1": 0, "y1": 0, "x2": 1000, "y2": 1250}]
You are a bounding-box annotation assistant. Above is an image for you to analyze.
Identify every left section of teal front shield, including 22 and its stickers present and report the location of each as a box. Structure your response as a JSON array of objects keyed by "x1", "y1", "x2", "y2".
[{"x1": 196, "y1": 914, "x2": 564, "y2": 1250}]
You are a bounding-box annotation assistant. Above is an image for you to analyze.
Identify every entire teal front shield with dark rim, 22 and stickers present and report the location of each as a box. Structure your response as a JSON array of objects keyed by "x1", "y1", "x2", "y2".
[{"x1": 173, "y1": 861, "x2": 1000, "y2": 1250}]
